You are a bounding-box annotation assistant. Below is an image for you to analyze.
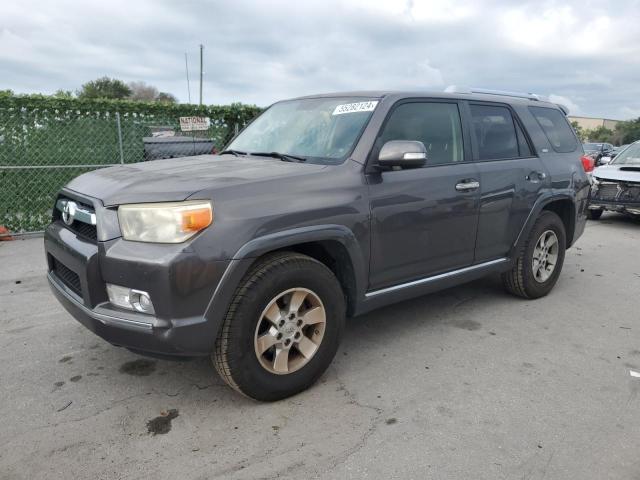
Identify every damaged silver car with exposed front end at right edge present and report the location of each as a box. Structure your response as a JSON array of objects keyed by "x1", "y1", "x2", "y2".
[{"x1": 589, "y1": 141, "x2": 640, "y2": 220}]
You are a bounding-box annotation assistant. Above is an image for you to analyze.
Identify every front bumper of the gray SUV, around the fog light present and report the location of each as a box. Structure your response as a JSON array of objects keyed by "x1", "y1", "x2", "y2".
[{"x1": 44, "y1": 212, "x2": 234, "y2": 357}]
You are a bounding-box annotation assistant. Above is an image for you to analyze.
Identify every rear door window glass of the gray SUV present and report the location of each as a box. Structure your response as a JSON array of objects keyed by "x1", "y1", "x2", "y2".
[{"x1": 470, "y1": 104, "x2": 520, "y2": 160}]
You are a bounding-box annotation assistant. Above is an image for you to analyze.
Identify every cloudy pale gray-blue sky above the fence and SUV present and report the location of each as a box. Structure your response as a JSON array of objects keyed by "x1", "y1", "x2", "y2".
[{"x1": 0, "y1": 0, "x2": 640, "y2": 120}]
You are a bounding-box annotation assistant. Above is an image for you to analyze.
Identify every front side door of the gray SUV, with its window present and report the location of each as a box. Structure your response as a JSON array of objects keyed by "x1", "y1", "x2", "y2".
[{"x1": 368, "y1": 101, "x2": 480, "y2": 290}]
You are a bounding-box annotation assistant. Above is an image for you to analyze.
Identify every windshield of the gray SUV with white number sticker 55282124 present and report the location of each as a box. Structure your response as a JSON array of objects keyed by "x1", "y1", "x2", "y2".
[{"x1": 227, "y1": 97, "x2": 378, "y2": 164}]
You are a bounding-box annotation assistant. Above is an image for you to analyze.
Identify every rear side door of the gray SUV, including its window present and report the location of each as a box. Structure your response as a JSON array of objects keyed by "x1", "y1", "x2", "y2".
[{"x1": 467, "y1": 102, "x2": 549, "y2": 263}]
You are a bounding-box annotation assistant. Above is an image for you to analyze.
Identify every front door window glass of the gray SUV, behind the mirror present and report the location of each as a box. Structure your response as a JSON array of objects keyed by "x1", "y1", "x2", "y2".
[{"x1": 377, "y1": 102, "x2": 464, "y2": 165}]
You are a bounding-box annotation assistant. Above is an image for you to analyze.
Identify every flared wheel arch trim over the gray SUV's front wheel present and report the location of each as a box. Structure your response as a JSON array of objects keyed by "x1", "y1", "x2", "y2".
[{"x1": 204, "y1": 224, "x2": 368, "y2": 346}]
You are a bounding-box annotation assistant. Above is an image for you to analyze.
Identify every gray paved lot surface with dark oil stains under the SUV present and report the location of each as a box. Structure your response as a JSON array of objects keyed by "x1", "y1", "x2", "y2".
[{"x1": 0, "y1": 214, "x2": 640, "y2": 480}]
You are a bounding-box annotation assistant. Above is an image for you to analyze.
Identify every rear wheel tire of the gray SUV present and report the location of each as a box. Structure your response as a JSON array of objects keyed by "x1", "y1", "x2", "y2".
[{"x1": 502, "y1": 210, "x2": 566, "y2": 299}]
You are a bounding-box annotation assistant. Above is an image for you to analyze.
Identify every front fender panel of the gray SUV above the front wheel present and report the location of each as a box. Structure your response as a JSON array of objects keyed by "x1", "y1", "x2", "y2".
[{"x1": 192, "y1": 160, "x2": 370, "y2": 338}]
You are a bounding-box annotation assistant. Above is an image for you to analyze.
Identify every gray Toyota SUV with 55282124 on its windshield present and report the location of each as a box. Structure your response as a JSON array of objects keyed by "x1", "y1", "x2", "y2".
[{"x1": 44, "y1": 92, "x2": 593, "y2": 401}]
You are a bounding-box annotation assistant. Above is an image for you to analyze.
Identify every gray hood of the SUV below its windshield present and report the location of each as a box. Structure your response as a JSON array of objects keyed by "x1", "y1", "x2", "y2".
[{"x1": 66, "y1": 155, "x2": 326, "y2": 206}]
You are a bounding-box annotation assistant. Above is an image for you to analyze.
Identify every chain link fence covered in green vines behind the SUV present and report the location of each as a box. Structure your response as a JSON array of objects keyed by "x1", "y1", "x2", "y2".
[{"x1": 0, "y1": 98, "x2": 259, "y2": 236}]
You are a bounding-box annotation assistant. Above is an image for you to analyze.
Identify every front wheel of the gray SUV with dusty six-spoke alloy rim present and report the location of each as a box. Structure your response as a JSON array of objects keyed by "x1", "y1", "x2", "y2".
[{"x1": 212, "y1": 252, "x2": 346, "y2": 401}]
